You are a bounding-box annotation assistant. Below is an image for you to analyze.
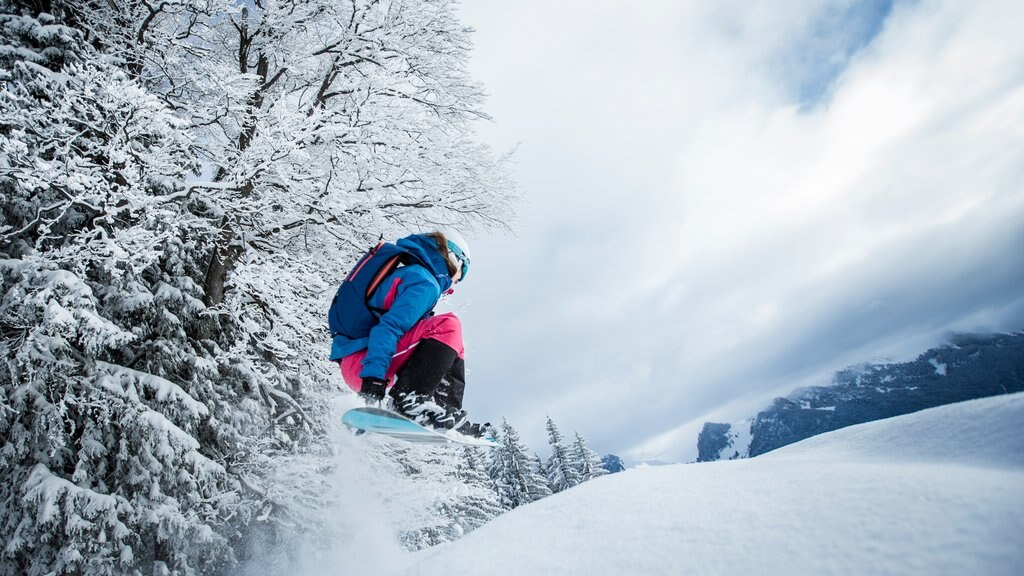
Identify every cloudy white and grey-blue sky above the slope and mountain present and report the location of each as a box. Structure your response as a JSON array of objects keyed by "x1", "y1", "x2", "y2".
[{"x1": 452, "y1": 0, "x2": 1024, "y2": 461}]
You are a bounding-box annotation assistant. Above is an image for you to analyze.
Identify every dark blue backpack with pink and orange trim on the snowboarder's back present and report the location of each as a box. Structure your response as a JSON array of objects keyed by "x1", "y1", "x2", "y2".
[{"x1": 328, "y1": 241, "x2": 421, "y2": 339}]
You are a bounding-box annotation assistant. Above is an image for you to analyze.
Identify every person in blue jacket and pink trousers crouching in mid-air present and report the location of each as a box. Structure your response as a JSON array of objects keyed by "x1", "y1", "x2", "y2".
[{"x1": 329, "y1": 231, "x2": 493, "y2": 437}]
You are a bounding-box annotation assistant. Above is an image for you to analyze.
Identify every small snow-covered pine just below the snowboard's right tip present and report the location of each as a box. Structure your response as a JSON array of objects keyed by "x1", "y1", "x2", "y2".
[{"x1": 487, "y1": 420, "x2": 551, "y2": 508}]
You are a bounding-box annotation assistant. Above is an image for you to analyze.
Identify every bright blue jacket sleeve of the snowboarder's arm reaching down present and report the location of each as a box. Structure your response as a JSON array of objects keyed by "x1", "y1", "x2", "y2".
[{"x1": 359, "y1": 265, "x2": 440, "y2": 378}]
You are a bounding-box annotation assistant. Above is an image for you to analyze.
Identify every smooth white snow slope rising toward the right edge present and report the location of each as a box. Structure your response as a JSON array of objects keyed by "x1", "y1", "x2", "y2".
[{"x1": 400, "y1": 394, "x2": 1024, "y2": 576}]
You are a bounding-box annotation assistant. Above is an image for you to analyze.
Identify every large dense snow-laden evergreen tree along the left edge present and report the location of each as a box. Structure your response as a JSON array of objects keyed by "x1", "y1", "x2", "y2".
[{"x1": 0, "y1": 12, "x2": 237, "y2": 575}]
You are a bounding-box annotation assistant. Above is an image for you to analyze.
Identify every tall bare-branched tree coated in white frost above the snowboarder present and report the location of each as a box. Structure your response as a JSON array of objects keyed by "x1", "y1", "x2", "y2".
[{"x1": 59, "y1": 0, "x2": 520, "y2": 305}]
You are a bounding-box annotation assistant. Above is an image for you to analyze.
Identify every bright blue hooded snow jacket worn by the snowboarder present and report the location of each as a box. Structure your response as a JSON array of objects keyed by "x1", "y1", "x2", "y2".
[{"x1": 331, "y1": 234, "x2": 452, "y2": 378}]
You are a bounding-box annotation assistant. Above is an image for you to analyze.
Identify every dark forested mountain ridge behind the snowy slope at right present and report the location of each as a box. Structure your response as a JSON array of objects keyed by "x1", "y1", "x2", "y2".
[{"x1": 697, "y1": 332, "x2": 1024, "y2": 462}]
